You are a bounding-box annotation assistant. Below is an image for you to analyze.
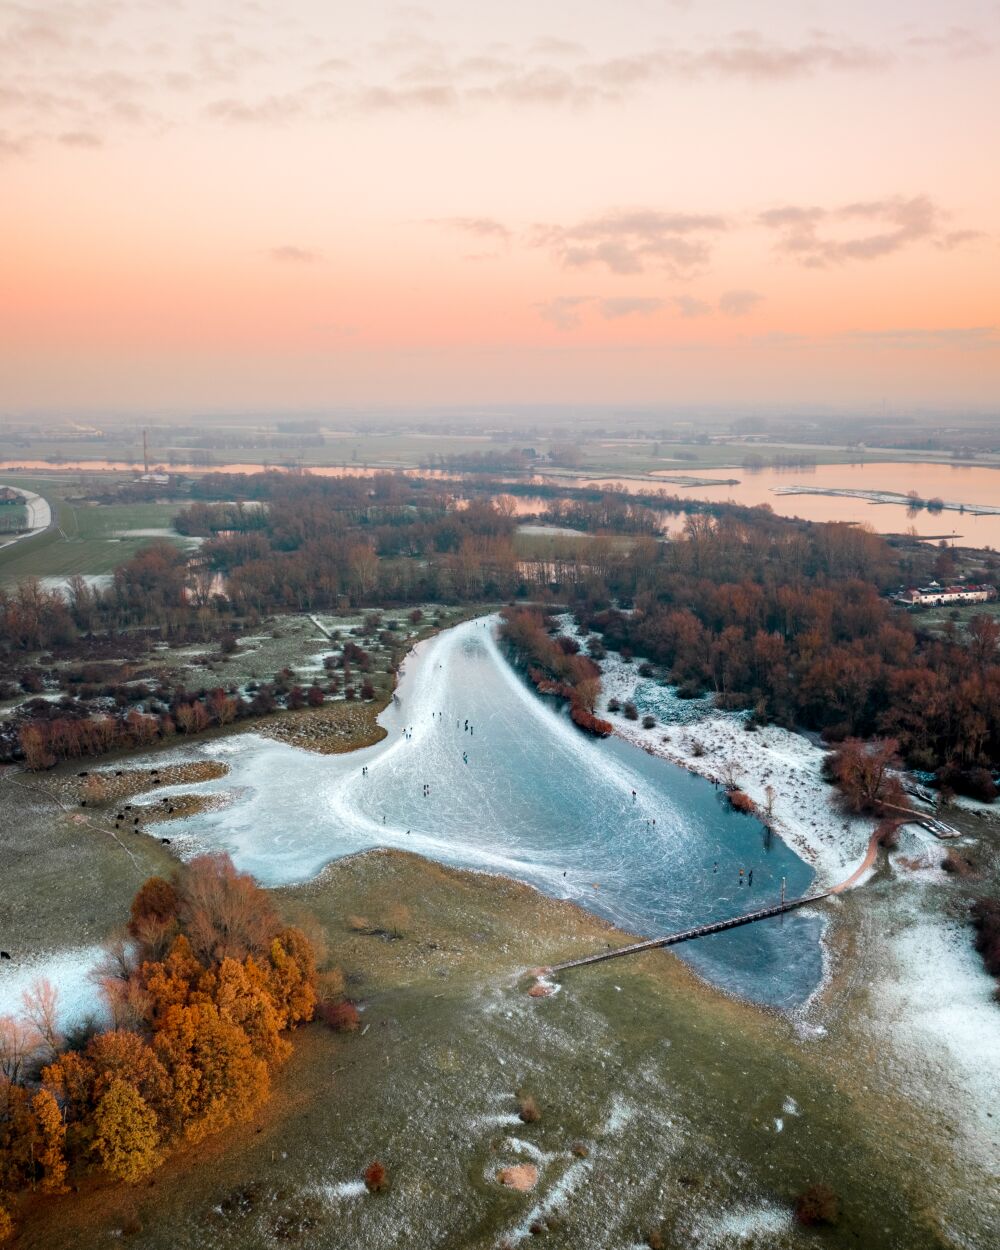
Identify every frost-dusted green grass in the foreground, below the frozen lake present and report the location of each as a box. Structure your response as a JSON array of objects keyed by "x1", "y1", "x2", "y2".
[{"x1": 11, "y1": 851, "x2": 989, "y2": 1250}]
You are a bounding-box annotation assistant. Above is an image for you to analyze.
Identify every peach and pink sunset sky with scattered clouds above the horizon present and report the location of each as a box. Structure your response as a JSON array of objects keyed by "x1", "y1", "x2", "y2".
[{"x1": 0, "y1": 0, "x2": 1000, "y2": 415}]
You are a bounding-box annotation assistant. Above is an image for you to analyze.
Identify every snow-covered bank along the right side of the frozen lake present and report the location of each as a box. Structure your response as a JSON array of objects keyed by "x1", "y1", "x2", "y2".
[{"x1": 585, "y1": 635, "x2": 1000, "y2": 1190}]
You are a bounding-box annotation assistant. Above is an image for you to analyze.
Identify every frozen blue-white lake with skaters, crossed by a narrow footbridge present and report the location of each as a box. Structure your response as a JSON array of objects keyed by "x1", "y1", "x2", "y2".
[{"x1": 158, "y1": 621, "x2": 823, "y2": 1006}]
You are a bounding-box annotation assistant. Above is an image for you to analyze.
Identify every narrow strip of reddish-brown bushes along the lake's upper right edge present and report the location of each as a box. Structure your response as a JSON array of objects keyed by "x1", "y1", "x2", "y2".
[{"x1": 500, "y1": 608, "x2": 614, "y2": 738}]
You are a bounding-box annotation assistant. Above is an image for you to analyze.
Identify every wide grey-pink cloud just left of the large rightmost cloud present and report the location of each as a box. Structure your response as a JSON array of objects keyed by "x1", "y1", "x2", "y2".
[{"x1": 531, "y1": 209, "x2": 726, "y2": 276}]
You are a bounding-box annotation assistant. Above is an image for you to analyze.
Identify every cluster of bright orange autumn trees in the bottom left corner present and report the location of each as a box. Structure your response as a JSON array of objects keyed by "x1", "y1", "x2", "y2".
[{"x1": 0, "y1": 855, "x2": 318, "y2": 1240}]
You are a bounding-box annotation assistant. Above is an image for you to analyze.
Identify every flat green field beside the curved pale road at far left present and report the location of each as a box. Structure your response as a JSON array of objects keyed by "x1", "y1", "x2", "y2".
[{"x1": 0, "y1": 474, "x2": 185, "y2": 584}]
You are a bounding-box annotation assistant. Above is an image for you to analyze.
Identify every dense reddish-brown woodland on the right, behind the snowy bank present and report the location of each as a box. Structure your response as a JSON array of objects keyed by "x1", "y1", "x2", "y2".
[{"x1": 571, "y1": 518, "x2": 1000, "y2": 798}]
